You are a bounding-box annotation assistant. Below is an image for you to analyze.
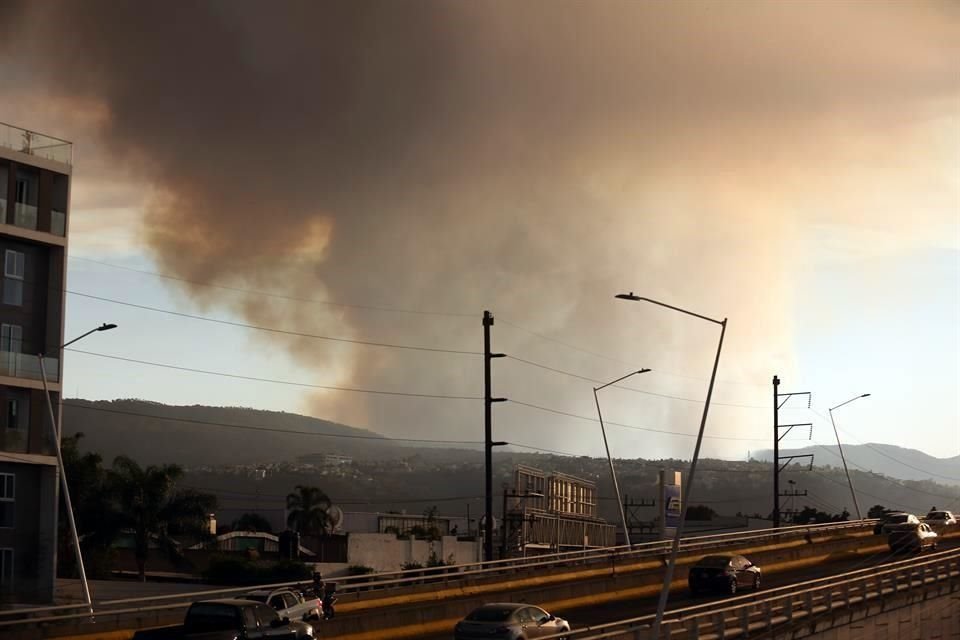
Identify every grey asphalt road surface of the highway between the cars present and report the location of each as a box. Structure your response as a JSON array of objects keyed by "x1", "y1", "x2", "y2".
[{"x1": 422, "y1": 540, "x2": 960, "y2": 640}]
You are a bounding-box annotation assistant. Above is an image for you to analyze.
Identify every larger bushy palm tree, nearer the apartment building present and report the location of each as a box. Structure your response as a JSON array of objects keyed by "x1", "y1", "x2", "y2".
[{"x1": 107, "y1": 456, "x2": 216, "y2": 580}]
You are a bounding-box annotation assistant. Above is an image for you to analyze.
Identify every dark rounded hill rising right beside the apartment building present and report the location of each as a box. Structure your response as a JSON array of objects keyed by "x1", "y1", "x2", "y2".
[{"x1": 63, "y1": 399, "x2": 398, "y2": 466}]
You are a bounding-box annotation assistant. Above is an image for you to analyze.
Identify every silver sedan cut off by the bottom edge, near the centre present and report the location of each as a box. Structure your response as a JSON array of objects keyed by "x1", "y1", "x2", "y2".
[{"x1": 453, "y1": 602, "x2": 570, "y2": 640}]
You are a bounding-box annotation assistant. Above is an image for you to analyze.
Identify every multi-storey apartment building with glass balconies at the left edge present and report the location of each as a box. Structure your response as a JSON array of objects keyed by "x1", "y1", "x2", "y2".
[{"x1": 0, "y1": 123, "x2": 72, "y2": 603}]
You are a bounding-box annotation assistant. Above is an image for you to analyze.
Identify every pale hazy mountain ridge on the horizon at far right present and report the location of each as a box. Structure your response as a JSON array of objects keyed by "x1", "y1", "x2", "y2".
[{"x1": 753, "y1": 443, "x2": 960, "y2": 486}]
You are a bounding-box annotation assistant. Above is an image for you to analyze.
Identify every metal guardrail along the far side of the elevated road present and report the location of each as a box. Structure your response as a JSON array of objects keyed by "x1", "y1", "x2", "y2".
[{"x1": 0, "y1": 520, "x2": 877, "y2": 633}]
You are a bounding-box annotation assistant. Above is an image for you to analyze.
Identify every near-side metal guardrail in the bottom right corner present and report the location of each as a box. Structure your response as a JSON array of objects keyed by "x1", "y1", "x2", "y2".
[{"x1": 545, "y1": 549, "x2": 960, "y2": 640}]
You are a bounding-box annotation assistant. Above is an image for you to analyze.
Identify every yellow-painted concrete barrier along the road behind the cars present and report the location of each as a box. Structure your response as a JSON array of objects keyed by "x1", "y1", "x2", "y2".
[{"x1": 33, "y1": 530, "x2": 960, "y2": 640}]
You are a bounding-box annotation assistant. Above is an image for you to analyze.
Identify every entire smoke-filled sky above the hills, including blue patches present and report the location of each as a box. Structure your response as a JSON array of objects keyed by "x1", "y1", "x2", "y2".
[{"x1": 0, "y1": 1, "x2": 960, "y2": 463}]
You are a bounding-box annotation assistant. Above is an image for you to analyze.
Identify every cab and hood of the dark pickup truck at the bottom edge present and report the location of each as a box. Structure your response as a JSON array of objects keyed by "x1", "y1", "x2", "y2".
[{"x1": 183, "y1": 599, "x2": 314, "y2": 640}]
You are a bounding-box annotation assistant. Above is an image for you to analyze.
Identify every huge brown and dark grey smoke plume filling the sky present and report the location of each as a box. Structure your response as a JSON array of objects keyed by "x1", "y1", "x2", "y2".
[{"x1": 0, "y1": 1, "x2": 960, "y2": 460}]
